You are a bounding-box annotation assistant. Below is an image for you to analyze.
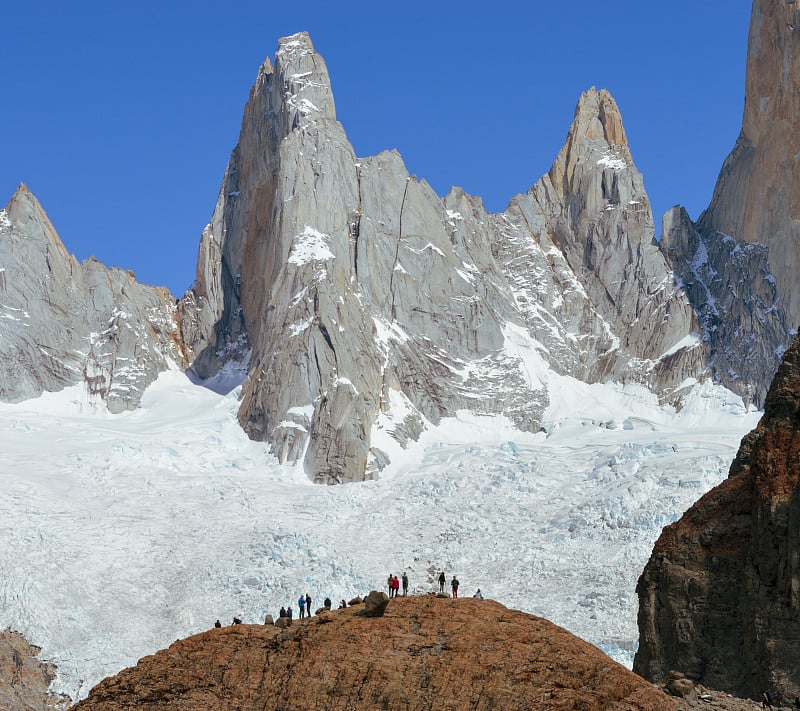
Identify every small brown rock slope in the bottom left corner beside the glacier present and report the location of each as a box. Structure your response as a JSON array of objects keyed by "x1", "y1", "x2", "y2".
[{"x1": 0, "y1": 630, "x2": 71, "y2": 711}]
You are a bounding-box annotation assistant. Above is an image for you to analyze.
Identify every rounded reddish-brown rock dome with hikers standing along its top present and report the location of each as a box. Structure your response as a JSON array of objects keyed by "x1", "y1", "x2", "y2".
[{"x1": 75, "y1": 596, "x2": 678, "y2": 711}]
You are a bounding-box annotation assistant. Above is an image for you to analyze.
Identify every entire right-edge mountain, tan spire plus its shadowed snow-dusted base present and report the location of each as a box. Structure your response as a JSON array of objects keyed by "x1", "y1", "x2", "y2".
[{"x1": 662, "y1": 0, "x2": 800, "y2": 406}]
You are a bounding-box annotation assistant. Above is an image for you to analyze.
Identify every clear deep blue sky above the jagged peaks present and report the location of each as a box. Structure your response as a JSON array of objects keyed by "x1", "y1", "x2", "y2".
[{"x1": 0, "y1": 0, "x2": 751, "y2": 295}]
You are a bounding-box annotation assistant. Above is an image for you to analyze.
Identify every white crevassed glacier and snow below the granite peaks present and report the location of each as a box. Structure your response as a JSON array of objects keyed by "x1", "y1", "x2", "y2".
[{"x1": 0, "y1": 372, "x2": 761, "y2": 698}]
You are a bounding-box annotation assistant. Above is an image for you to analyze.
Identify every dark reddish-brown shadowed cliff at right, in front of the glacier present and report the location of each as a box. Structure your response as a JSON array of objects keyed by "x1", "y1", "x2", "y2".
[{"x1": 634, "y1": 339, "x2": 800, "y2": 699}]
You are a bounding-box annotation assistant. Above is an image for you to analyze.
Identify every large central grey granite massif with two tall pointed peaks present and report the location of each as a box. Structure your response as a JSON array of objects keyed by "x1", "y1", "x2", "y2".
[{"x1": 179, "y1": 33, "x2": 706, "y2": 483}]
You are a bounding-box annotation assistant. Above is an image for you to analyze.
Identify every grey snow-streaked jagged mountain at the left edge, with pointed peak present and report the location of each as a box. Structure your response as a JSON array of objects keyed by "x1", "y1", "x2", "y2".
[{"x1": 0, "y1": 185, "x2": 184, "y2": 412}]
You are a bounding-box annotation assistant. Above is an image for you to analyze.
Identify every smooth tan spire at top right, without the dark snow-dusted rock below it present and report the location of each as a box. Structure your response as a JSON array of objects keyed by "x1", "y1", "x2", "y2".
[{"x1": 699, "y1": 0, "x2": 800, "y2": 328}]
